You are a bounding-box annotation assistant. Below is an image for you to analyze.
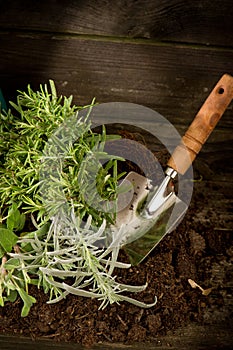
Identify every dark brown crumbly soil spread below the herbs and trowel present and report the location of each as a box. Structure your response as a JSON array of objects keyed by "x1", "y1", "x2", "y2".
[{"x1": 0, "y1": 129, "x2": 233, "y2": 346}]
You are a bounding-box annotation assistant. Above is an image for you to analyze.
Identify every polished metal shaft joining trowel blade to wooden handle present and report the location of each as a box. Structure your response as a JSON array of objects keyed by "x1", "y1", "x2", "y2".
[{"x1": 142, "y1": 167, "x2": 177, "y2": 219}]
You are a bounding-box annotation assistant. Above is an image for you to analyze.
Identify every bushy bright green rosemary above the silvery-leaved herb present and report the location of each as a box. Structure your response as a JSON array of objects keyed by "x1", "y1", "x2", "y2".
[{"x1": 0, "y1": 81, "x2": 123, "y2": 224}]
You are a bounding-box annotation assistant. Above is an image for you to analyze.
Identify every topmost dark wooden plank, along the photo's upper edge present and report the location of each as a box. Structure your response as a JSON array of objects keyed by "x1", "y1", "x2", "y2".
[{"x1": 0, "y1": 0, "x2": 233, "y2": 47}]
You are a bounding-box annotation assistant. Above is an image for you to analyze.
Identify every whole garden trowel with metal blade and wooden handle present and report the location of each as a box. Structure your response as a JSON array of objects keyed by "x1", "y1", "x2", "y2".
[{"x1": 113, "y1": 74, "x2": 233, "y2": 265}]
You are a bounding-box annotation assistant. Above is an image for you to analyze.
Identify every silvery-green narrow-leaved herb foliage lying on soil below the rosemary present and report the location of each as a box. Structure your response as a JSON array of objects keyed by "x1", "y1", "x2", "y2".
[{"x1": 10, "y1": 206, "x2": 156, "y2": 308}]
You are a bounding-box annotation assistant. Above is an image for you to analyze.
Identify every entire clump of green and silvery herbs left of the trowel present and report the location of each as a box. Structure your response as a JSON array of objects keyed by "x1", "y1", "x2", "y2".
[{"x1": 0, "y1": 81, "x2": 156, "y2": 316}]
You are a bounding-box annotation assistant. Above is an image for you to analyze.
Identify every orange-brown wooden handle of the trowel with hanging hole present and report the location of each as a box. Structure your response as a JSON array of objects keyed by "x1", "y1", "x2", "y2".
[{"x1": 168, "y1": 74, "x2": 233, "y2": 174}]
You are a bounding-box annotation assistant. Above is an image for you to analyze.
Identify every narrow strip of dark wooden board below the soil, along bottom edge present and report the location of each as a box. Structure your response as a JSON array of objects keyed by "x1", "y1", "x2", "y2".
[{"x1": 0, "y1": 324, "x2": 233, "y2": 350}]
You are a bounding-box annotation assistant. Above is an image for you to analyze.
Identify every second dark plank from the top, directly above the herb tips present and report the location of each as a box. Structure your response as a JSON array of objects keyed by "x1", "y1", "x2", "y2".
[{"x1": 0, "y1": 33, "x2": 233, "y2": 134}]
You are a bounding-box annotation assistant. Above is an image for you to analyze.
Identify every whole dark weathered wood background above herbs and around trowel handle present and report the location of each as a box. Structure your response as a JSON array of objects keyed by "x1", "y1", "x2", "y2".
[{"x1": 0, "y1": 0, "x2": 233, "y2": 348}]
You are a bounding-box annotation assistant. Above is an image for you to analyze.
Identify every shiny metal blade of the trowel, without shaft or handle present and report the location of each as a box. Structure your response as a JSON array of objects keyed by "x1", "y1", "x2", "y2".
[{"x1": 115, "y1": 172, "x2": 188, "y2": 265}]
